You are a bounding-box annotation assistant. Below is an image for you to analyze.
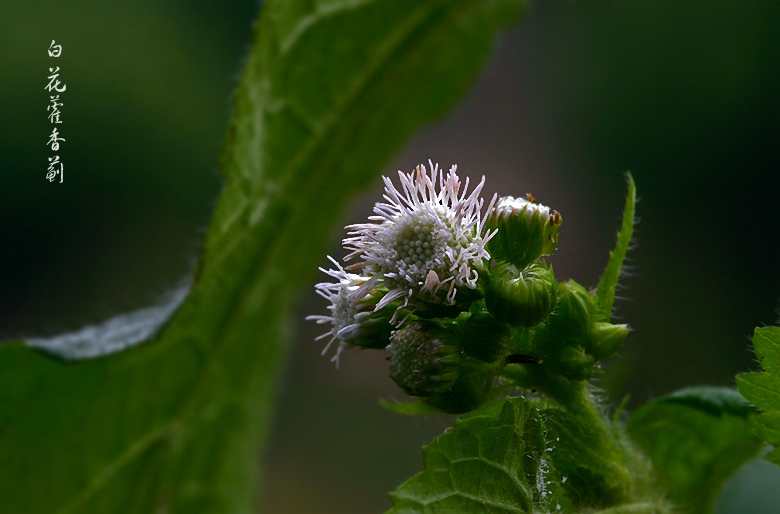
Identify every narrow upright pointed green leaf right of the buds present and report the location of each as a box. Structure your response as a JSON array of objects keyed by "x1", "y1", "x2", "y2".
[{"x1": 596, "y1": 173, "x2": 636, "y2": 321}]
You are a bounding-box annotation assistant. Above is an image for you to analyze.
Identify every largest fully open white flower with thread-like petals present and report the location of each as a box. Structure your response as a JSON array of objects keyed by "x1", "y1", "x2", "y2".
[{"x1": 344, "y1": 161, "x2": 496, "y2": 316}]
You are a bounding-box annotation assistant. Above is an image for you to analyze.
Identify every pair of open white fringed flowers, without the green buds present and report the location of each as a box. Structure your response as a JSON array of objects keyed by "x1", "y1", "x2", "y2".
[{"x1": 307, "y1": 161, "x2": 496, "y2": 362}]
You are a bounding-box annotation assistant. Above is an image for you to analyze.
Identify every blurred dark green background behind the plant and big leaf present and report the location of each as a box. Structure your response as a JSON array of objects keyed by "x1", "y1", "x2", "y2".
[{"x1": 0, "y1": 0, "x2": 780, "y2": 513}]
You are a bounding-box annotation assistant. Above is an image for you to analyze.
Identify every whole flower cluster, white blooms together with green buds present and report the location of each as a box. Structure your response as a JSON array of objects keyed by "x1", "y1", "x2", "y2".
[{"x1": 307, "y1": 162, "x2": 628, "y2": 413}]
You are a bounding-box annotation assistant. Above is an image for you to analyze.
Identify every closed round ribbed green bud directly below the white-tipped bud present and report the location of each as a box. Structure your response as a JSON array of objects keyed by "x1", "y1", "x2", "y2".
[{"x1": 485, "y1": 261, "x2": 558, "y2": 327}]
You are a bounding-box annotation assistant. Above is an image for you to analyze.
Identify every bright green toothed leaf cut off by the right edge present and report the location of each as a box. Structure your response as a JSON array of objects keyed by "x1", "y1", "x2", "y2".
[{"x1": 737, "y1": 327, "x2": 780, "y2": 466}]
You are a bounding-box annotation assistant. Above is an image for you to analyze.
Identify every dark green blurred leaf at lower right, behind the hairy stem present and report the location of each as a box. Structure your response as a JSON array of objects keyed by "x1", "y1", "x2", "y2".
[{"x1": 628, "y1": 387, "x2": 763, "y2": 513}]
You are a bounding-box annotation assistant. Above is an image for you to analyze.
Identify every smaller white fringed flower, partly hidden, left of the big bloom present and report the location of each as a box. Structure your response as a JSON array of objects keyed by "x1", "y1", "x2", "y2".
[{"x1": 306, "y1": 256, "x2": 391, "y2": 366}]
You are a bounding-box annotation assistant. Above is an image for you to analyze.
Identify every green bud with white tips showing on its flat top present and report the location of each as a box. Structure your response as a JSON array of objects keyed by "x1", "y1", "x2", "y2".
[{"x1": 485, "y1": 195, "x2": 563, "y2": 269}]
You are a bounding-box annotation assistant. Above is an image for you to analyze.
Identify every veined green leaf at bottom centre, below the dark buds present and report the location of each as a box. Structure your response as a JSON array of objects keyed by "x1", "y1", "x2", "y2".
[{"x1": 389, "y1": 398, "x2": 557, "y2": 514}]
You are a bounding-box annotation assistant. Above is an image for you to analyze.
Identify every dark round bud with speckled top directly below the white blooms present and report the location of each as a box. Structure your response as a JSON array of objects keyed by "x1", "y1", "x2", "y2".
[{"x1": 387, "y1": 322, "x2": 460, "y2": 397}]
